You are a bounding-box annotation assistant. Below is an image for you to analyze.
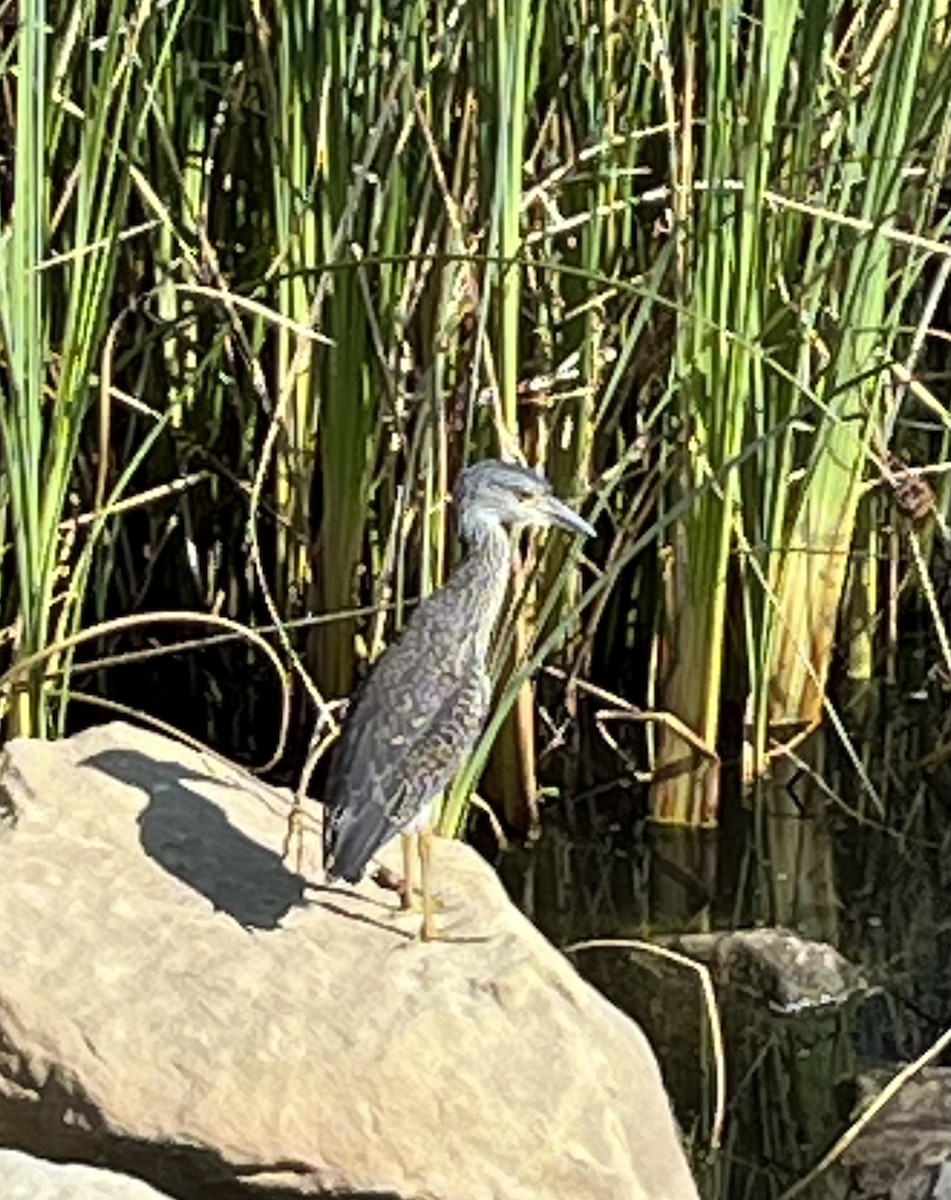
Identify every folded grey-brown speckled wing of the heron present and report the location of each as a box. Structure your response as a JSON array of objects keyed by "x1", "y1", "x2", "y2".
[{"x1": 325, "y1": 643, "x2": 491, "y2": 881}]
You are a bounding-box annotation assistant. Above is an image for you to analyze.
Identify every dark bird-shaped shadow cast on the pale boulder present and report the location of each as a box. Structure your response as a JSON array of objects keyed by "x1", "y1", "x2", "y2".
[{"x1": 82, "y1": 750, "x2": 307, "y2": 930}]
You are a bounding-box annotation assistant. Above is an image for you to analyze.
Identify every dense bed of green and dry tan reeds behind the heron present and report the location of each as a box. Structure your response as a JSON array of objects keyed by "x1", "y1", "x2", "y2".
[{"x1": 0, "y1": 0, "x2": 951, "y2": 832}]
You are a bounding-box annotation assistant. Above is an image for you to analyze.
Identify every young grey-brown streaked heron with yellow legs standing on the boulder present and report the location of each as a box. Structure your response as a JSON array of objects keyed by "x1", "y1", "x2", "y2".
[{"x1": 324, "y1": 460, "x2": 594, "y2": 940}]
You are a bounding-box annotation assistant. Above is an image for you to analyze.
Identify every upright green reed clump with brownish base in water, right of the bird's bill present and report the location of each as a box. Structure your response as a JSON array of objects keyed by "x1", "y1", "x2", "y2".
[{"x1": 652, "y1": 0, "x2": 795, "y2": 824}]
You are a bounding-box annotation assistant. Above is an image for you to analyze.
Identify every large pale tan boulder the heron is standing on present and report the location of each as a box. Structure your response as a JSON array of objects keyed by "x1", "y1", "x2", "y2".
[{"x1": 0, "y1": 725, "x2": 696, "y2": 1200}]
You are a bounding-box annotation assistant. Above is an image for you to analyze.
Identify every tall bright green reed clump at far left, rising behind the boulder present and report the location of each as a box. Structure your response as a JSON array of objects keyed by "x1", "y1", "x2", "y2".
[{"x1": 0, "y1": 0, "x2": 146, "y2": 736}]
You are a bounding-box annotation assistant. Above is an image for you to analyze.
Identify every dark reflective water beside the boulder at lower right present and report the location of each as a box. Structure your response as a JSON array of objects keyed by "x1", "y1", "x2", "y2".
[{"x1": 501, "y1": 694, "x2": 951, "y2": 1200}]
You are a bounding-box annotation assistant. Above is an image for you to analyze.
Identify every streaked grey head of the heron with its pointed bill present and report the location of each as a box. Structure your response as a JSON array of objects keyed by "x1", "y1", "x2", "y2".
[{"x1": 455, "y1": 458, "x2": 594, "y2": 540}]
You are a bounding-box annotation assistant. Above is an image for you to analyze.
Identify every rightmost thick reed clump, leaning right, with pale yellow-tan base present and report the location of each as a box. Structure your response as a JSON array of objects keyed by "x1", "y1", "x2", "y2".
[{"x1": 768, "y1": 4, "x2": 950, "y2": 739}]
